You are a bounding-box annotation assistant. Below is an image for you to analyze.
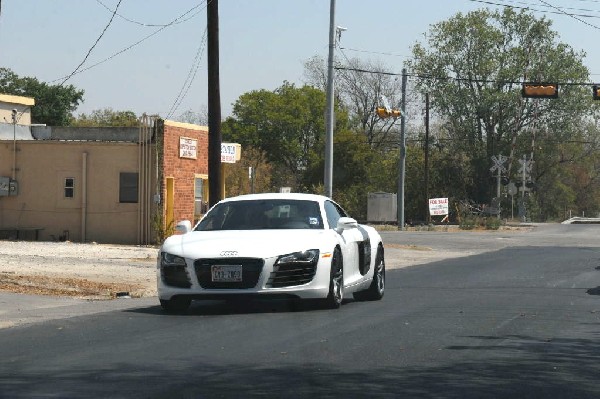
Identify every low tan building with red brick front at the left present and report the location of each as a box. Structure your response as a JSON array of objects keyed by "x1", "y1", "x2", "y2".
[{"x1": 0, "y1": 95, "x2": 221, "y2": 244}]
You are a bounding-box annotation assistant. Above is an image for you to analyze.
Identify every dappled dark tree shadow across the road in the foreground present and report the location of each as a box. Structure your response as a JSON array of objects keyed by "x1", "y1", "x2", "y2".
[{"x1": 0, "y1": 335, "x2": 600, "y2": 399}]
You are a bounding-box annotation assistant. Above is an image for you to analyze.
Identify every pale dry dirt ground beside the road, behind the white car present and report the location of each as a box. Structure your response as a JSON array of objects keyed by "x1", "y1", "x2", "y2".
[{"x1": 0, "y1": 241, "x2": 470, "y2": 299}]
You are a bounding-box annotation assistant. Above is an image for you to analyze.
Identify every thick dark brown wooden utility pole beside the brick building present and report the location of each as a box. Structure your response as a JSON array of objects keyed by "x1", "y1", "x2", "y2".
[{"x1": 206, "y1": 0, "x2": 223, "y2": 207}]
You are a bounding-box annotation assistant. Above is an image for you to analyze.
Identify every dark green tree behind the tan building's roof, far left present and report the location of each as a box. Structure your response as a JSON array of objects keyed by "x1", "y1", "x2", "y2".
[{"x1": 0, "y1": 68, "x2": 84, "y2": 126}]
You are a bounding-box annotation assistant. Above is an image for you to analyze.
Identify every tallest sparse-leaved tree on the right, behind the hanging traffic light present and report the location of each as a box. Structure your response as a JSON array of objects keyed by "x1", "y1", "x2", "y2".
[{"x1": 407, "y1": 7, "x2": 591, "y2": 208}]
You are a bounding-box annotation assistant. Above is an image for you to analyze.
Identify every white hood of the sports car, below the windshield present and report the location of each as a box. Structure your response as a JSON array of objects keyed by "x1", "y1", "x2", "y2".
[{"x1": 161, "y1": 229, "x2": 333, "y2": 259}]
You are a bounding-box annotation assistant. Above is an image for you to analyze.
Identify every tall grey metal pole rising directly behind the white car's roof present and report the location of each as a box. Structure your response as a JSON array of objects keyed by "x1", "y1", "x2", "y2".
[{"x1": 324, "y1": 0, "x2": 335, "y2": 198}]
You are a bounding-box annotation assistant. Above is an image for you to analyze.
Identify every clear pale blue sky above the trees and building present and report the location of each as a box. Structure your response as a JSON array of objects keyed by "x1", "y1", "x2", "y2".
[{"x1": 0, "y1": 0, "x2": 600, "y2": 117}]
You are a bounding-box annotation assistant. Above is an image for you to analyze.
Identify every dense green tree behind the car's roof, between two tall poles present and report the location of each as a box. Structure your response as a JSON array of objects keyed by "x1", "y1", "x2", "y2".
[{"x1": 223, "y1": 82, "x2": 345, "y2": 190}]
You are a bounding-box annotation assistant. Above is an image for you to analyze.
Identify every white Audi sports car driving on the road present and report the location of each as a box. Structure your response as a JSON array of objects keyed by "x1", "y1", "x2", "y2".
[{"x1": 157, "y1": 194, "x2": 385, "y2": 312}]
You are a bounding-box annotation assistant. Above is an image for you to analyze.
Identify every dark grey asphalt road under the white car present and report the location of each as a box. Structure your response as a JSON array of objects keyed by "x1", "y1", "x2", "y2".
[{"x1": 0, "y1": 225, "x2": 600, "y2": 398}]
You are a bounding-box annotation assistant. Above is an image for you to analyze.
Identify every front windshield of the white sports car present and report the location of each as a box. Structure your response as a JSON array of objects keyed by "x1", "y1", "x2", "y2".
[{"x1": 195, "y1": 199, "x2": 323, "y2": 231}]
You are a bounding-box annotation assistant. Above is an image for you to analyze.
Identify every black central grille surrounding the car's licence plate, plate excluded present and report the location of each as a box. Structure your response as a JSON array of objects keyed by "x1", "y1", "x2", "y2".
[{"x1": 194, "y1": 258, "x2": 265, "y2": 289}]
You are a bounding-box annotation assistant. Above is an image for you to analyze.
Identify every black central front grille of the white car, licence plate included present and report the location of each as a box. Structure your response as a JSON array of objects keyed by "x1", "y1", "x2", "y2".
[{"x1": 194, "y1": 258, "x2": 265, "y2": 289}]
